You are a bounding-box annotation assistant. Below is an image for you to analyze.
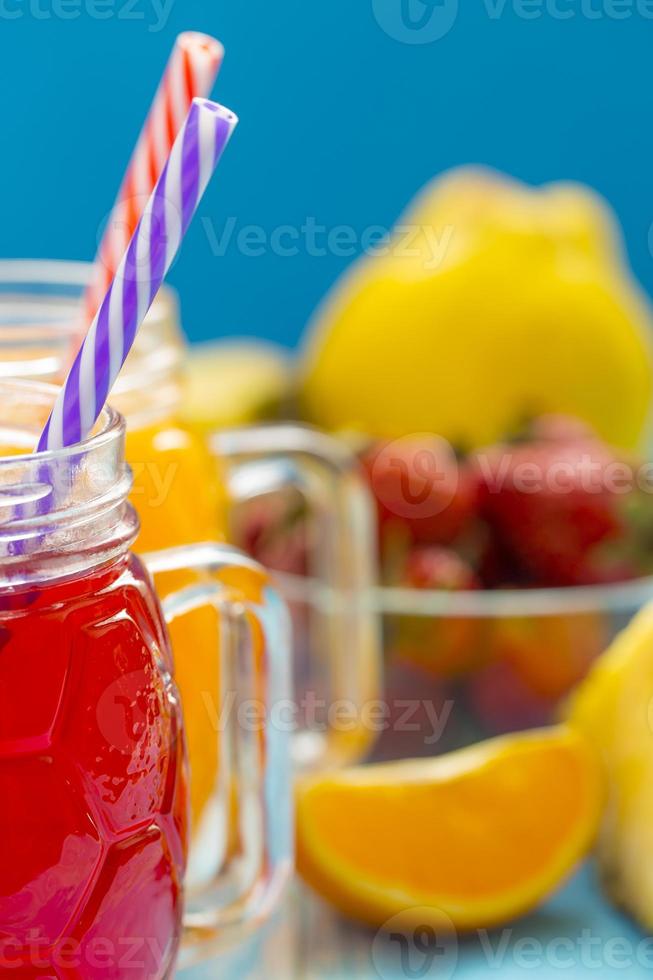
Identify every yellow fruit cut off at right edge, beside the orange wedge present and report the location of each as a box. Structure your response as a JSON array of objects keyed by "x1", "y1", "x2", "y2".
[{"x1": 569, "y1": 605, "x2": 653, "y2": 930}]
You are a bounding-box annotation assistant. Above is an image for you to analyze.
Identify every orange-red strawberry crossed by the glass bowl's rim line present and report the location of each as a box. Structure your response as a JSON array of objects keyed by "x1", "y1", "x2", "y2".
[{"x1": 396, "y1": 546, "x2": 480, "y2": 677}]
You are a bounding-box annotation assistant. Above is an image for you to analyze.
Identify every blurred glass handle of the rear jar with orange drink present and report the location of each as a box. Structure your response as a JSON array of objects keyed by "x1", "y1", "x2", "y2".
[{"x1": 210, "y1": 423, "x2": 382, "y2": 768}]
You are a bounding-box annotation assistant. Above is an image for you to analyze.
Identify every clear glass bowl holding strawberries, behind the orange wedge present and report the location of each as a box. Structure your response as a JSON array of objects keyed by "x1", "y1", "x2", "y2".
[{"x1": 258, "y1": 573, "x2": 653, "y2": 761}]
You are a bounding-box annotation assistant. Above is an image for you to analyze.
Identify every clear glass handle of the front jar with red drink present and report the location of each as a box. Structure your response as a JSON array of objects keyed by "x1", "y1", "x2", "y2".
[{"x1": 143, "y1": 543, "x2": 293, "y2": 966}]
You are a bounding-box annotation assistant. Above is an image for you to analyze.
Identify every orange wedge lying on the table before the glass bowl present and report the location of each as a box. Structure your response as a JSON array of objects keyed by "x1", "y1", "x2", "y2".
[{"x1": 297, "y1": 725, "x2": 602, "y2": 930}]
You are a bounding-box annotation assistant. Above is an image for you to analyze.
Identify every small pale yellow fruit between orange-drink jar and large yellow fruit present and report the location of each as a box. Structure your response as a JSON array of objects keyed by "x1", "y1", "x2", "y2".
[{"x1": 184, "y1": 341, "x2": 292, "y2": 432}]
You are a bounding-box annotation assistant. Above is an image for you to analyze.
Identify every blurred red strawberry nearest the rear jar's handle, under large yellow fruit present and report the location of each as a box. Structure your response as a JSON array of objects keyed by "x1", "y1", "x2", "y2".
[{"x1": 363, "y1": 435, "x2": 478, "y2": 544}]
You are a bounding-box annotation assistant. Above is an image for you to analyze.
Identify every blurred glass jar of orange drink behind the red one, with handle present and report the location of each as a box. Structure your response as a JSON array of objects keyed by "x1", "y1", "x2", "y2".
[{"x1": 0, "y1": 260, "x2": 381, "y2": 804}]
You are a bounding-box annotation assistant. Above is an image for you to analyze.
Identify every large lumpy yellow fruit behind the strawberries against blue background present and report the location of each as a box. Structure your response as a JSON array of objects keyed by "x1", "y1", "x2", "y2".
[{"x1": 302, "y1": 170, "x2": 653, "y2": 448}]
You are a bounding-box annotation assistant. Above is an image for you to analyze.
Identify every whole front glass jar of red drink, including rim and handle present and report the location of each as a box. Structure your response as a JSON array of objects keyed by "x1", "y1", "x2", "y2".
[{"x1": 0, "y1": 381, "x2": 292, "y2": 980}]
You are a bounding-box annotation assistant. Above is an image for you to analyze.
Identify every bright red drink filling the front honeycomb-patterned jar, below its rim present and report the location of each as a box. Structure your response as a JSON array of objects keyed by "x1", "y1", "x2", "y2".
[{"x1": 0, "y1": 558, "x2": 187, "y2": 978}]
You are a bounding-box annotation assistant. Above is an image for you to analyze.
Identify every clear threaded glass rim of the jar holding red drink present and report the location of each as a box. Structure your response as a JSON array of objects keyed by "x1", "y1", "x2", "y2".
[{"x1": 0, "y1": 379, "x2": 138, "y2": 588}]
